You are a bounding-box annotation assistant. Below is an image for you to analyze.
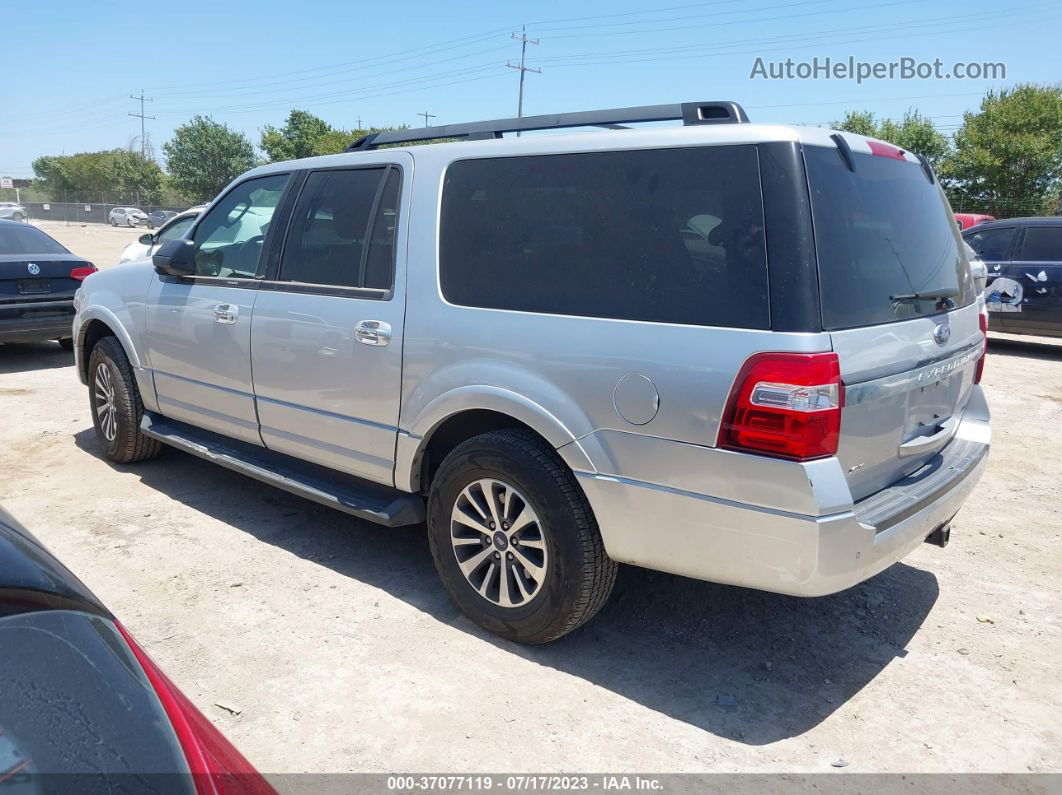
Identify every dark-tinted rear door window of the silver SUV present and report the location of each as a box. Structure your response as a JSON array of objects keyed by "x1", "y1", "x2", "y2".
[{"x1": 279, "y1": 168, "x2": 386, "y2": 287}]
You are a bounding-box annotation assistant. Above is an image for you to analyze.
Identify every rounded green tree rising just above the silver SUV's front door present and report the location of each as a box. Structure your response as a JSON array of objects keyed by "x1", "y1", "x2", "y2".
[{"x1": 162, "y1": 116, "x2": 256, "y2": 202}]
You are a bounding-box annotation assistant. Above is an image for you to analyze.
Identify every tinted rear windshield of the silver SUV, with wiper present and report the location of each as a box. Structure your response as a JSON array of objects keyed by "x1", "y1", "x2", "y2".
[{"x1": 804, "y1": 146, "x2": 974, "y2": 329}]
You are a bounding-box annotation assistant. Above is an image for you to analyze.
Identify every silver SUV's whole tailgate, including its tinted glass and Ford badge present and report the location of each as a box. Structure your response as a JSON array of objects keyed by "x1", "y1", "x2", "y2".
[{"x1": 805, "y1": 134, "x2": 984, "y2": 500}]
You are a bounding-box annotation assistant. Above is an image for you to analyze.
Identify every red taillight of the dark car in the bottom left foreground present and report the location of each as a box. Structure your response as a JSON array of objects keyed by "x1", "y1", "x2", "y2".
[{"x1": 115, "y1": 621, "x2": 276, "y2": 795}]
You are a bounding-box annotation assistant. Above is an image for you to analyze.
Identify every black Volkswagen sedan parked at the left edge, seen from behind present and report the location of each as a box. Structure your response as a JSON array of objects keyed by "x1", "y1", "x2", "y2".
[{"x1": 0, "y1": 221, "x2": 96, "y2": 350}]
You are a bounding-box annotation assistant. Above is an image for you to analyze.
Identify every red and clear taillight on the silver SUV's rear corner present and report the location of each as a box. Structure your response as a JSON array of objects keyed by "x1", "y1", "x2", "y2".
[{"x1": 720, "y1": 353, "x2": 844, "y2": 461}]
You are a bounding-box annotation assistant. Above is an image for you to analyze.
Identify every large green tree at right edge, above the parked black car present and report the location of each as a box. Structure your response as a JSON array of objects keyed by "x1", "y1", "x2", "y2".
[{"x1": 946, "y1": 85, "x2": 1062, "y2": 218}]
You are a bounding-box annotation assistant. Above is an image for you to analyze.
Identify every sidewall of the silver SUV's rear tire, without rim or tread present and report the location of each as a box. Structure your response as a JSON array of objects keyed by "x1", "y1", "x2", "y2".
[{"x1": 428, "y1": 445, "x2": 582, "y2": 641}]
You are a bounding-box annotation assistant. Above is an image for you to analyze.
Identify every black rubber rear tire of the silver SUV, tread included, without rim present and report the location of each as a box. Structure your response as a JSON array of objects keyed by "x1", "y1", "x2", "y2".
[{"x1": 428, "y1": 429, "x2": 617, "y2": 643}]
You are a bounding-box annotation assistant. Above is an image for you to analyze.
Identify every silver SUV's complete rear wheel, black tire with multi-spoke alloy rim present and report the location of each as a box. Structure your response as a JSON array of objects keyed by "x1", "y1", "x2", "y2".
[{"x1": 428, "y1": 429, "x2": 617, "y2": 643}]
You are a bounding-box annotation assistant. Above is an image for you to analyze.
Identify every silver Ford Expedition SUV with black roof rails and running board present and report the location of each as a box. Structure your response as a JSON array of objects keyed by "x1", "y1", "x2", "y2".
[{"x1": 74, "y1": 103, "x2": 990, "y2": 643}]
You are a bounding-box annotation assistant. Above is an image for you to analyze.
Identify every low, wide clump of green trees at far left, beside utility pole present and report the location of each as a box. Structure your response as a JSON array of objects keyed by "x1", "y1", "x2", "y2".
[{"x1": 33, "y1": 149, "x2": 162, "y2": 204}]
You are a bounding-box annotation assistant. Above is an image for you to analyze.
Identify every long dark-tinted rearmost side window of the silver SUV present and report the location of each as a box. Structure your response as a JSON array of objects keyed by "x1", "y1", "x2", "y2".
[{"x1": 440, "y1": 145, "x2": 770, "y2": 328}]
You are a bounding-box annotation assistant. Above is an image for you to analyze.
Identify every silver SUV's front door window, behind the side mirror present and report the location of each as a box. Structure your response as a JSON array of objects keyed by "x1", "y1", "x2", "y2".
[{"x1": 193, "y1": 174, "x2": 289, "y2": 279}]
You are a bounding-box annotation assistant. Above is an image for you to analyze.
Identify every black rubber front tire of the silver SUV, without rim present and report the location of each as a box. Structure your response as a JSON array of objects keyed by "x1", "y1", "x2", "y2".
[{"x1": 88, "y1": 336, "x2": 161, "y2": 464}]
